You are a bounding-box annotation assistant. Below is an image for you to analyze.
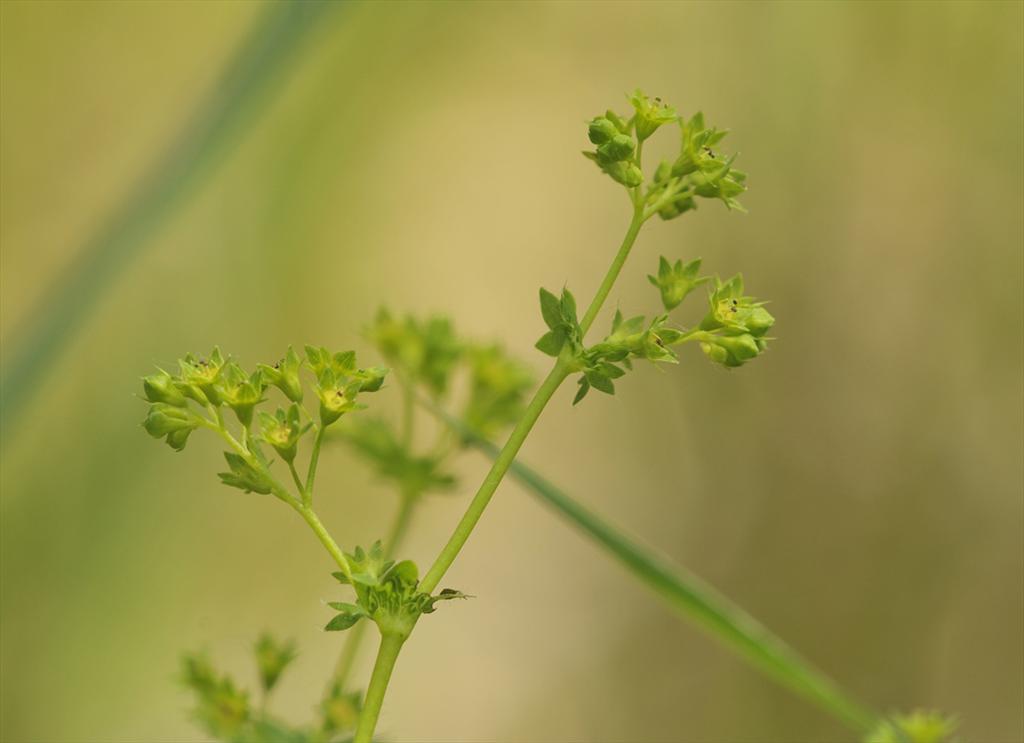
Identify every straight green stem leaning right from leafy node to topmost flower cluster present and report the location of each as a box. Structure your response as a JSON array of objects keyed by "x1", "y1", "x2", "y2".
[{"x1": 420, "y1": 207, "x2": 644, "y2": 594}]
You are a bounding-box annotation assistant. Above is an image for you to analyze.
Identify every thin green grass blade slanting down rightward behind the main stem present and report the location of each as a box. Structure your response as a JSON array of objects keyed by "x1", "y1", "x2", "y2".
[{"x1": 428, "y1": 404, "x2": 879, "y2": 732}]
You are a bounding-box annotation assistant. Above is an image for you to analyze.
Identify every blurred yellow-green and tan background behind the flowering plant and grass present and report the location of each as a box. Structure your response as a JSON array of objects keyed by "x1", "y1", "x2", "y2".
[{"x1": 0, "y1": 2, "x2": 1024, "y2": 742}]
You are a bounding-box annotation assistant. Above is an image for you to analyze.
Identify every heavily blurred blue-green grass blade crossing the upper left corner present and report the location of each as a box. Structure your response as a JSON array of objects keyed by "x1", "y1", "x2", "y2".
[{"x1": 0, "y1": 2, "x2": 340, "y2": 432}]
